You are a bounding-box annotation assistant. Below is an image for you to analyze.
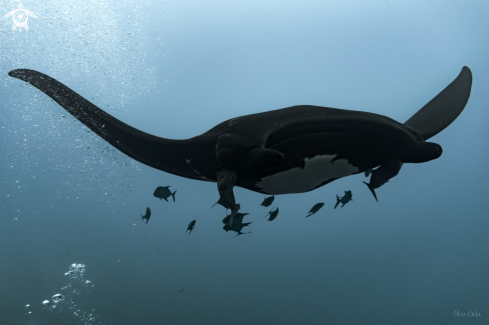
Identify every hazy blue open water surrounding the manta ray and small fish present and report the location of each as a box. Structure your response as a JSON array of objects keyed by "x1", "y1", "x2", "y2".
[{"x1": 0, "y1": 0, "x2": 489, "y2": 325}]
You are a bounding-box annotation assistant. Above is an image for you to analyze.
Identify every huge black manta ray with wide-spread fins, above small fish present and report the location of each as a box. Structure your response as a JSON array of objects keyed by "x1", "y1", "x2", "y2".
[{"x1": 9, "y1": 67, "x2": 472, "y2": 220}]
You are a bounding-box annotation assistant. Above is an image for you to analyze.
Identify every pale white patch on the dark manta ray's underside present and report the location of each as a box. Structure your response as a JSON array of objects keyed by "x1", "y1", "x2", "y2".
[{"x1": 255, "y1": 155, "x2": 360, "y2": 195}]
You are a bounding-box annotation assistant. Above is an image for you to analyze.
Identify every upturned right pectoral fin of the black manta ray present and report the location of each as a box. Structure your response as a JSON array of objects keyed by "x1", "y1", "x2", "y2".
[{"x1": 404, "y1": 67, "x2": 472, "y2": 140}]
